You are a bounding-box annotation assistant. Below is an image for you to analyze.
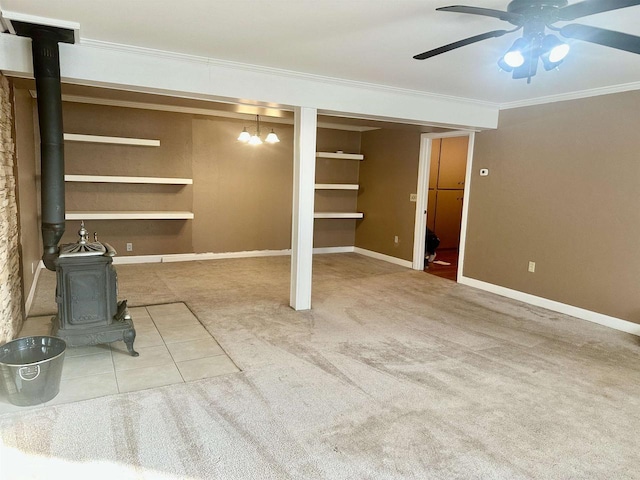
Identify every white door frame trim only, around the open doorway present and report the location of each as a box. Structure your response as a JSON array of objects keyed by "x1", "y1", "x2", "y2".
[{"x1": 411, "y1": 130, "x2": 475, "y2": 278}]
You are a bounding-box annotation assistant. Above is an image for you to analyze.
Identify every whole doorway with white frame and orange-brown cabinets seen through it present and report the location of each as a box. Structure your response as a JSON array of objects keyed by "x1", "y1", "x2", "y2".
[{"x1": 413, "y1": 131, "x2": 474, "y2": 281}]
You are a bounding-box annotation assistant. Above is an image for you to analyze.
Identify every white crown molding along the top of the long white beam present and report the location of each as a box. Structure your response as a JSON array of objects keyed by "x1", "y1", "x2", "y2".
[{"x1": 80, "y1": 39, "x2": 500, "y2": 108}]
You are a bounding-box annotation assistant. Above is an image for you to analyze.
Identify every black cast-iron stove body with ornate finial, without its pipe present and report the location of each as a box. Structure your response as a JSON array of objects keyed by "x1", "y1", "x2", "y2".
[{"x1": 52, "y1": 222, "x2": 138, "y2": 356}]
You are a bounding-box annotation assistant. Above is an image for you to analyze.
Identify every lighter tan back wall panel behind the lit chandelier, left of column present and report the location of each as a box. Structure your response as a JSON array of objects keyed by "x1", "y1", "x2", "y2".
[{"x1": 193, "y1": 118, "x2": 293, "y2": 253}]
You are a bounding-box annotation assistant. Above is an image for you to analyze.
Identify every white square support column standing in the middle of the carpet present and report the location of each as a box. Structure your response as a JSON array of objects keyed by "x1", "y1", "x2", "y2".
[{"x1": 289, "y1": 107, "x2": 318, "y2": 310}]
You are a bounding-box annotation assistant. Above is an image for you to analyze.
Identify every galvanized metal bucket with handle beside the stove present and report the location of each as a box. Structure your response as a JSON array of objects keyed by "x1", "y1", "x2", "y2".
[{"x1": 0, "y1": 336, "x2": 67, "y2": 406}]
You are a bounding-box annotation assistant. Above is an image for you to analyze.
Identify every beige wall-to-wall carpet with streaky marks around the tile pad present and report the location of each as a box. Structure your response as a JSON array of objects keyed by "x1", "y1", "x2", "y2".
[{"x1": 0, "y1": 254, "x2": 640, "y2": 480}]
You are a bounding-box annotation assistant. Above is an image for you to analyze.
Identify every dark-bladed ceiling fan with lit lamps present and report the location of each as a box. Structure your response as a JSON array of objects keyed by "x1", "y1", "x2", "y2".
[{"x1": 413, "y1": 0, "x2": 640, "y2": 83}]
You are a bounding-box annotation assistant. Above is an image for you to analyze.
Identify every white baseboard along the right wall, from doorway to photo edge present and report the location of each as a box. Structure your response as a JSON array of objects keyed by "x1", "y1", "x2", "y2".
[{"x1": 458, "y1": 276, "x2": 640, "y2": 336}]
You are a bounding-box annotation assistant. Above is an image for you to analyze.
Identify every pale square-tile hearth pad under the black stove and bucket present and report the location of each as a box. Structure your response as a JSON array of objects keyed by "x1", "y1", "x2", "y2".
[{"x1": 0, "y1": 303, "x2": 240, "y2": 414}]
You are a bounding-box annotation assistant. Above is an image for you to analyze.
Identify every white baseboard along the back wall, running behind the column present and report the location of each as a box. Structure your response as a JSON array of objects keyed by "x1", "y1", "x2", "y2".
[{"x1": 113, "y1": 246, "x2": 355, "y2": 265}]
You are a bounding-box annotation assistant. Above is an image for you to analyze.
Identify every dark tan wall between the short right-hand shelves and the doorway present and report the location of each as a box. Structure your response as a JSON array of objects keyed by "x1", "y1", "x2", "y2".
[{"x1": 356, "y1": 129, "x2": 420, "y2": 261}]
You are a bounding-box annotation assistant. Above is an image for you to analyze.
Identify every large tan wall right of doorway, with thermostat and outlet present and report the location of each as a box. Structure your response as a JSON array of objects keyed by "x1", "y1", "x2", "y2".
[{"x1": 464, "y1": 91, "x2": 640, "y2": 323}]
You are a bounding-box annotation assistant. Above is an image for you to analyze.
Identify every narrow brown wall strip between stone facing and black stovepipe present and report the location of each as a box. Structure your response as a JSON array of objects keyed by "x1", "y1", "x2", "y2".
[{"x1": 14, "y1": 85, "x2": 42, "y2": 298}]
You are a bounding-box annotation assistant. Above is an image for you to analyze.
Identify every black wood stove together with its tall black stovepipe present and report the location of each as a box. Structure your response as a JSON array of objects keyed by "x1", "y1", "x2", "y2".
[{"x1": 12, "y1": 21, "x2": 138, "y2": 356}]
